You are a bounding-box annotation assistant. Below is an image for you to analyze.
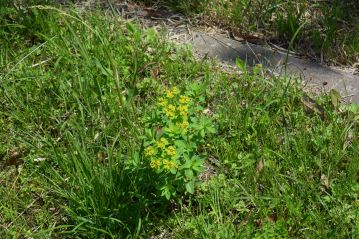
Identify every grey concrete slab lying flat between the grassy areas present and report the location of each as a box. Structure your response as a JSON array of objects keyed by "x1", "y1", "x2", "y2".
[{"x1": 191, "y1": 32, "x2": 359, "y2": 104}]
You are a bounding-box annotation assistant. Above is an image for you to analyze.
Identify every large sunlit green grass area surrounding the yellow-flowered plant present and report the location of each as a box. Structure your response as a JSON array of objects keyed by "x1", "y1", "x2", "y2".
[{"x1": 0, "y1": 2, "x2": 359, "y2": 238}]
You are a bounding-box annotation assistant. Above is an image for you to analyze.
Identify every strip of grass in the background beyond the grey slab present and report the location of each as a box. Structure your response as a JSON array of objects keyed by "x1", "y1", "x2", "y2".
[{"x1": 139, "y1": 0, "x2": 359, "y2": 64}]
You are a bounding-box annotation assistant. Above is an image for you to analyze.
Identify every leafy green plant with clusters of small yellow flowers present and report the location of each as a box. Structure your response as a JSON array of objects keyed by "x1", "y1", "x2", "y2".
[{"x1": 143, "y1": 87, "x2": 215, "y2": 199}]
